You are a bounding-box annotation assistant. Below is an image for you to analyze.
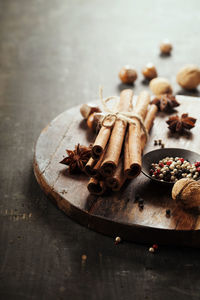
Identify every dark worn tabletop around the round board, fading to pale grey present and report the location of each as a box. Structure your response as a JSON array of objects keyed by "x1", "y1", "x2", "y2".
[{"x1": 0, "y1": 0, "x2": 200, "y2": 300}]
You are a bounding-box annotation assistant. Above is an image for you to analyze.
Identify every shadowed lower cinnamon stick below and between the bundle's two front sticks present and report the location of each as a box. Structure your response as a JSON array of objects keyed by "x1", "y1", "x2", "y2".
[{"x1": 106, "y1": 157, "x2": 126, "y2": 191}]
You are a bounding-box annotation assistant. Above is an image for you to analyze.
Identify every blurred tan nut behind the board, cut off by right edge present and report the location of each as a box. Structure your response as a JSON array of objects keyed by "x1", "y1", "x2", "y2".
[{"x1": 176, "y1": 65, "x2": 200, "y2": 90}]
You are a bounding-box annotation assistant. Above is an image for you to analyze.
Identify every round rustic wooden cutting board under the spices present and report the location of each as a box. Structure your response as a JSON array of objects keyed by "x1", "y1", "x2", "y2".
[{"x1": 34, "y1": 96, "x2": 200, "y2": 247}]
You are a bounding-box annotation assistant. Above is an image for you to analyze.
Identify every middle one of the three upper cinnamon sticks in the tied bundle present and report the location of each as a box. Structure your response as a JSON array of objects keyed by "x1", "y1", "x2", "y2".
[{"x1": 101, "y1": 89, "x2": 133, "y2": 177}]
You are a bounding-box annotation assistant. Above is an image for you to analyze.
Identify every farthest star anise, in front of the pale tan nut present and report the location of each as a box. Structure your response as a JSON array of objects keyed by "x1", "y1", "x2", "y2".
[{"x1": 151, "y1": 94, "x2": 180, "y2": 112}]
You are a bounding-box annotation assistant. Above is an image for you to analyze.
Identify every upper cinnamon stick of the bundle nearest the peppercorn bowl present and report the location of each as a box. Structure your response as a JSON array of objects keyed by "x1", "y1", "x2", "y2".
[{"x1": 124, "y1": 91, "x2": 150, "y2": 178}]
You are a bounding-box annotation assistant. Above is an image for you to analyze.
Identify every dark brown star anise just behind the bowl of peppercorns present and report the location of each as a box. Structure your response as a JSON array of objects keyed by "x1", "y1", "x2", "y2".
[{"x1": 166, "y1": 114, "x2": 196, "y2": 133}]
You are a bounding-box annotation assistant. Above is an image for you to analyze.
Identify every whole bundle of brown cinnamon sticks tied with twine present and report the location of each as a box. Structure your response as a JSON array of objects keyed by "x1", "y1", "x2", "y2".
[{"x1": 85, "y1": 89, "x2": 157, "y2": 195}]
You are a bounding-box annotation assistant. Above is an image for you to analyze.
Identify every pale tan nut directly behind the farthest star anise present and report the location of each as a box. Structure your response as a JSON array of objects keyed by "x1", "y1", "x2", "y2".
[{"x1": 149, "y1": 77, "x2": 172, "y2": 95}]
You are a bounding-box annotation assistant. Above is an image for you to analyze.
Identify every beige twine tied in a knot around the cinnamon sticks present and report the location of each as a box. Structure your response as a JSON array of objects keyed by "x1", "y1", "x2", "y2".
[{"x1": 99, "y1": 87, "x2": 148, "y2": 139}]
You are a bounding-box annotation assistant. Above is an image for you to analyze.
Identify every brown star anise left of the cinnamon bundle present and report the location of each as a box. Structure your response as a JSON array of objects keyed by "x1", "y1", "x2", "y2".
[{"x1": 60, "y1": 144, "x2": 91, "y2": 174}]
